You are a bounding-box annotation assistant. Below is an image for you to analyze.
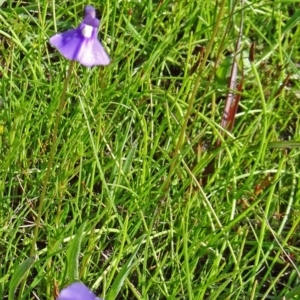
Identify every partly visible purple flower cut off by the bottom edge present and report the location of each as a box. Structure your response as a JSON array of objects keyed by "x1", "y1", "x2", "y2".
[{"x1": 56, "y1": 282, "x2": 102, "y2": 300}]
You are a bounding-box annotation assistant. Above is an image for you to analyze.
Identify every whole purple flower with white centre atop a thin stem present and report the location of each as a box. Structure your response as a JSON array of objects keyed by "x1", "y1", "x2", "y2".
[{"x1": 50, "y1": 6, "x2": 110, "y2": 67}]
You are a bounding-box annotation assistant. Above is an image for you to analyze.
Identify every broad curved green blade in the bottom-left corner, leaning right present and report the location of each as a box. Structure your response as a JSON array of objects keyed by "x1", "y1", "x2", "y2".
[{"x1": 8, "y1": 256, "x2": 35, "y2": 300}]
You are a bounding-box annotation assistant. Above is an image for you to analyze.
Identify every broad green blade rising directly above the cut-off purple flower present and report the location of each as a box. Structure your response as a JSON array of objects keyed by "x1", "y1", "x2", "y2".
[{"x1": 67, "y1": 222, "x2": 86, "y2": 282}]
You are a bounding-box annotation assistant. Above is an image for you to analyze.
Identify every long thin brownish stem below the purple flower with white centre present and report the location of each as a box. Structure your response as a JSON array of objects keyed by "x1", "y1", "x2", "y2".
[{"x1": 30, "y1": 61, "x2": 74, "y2": 256}]
